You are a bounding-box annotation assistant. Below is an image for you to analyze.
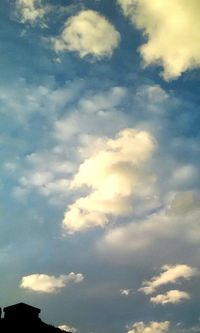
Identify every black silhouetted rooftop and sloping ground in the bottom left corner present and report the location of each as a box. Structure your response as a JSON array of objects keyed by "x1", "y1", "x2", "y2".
[{"x1": 0, "y1": 303, "x2": 70, "y2": 333}]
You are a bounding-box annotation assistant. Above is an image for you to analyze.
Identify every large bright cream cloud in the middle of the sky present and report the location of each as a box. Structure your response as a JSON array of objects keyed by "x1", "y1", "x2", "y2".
[{"x1": 63, "y1": 128, "x2": 156, "y2": 233}]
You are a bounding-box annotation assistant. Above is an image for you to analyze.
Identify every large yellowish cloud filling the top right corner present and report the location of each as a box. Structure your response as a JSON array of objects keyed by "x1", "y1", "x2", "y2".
[{"x1": 118, "y1": 0, "x2": 200, "y2": 80}]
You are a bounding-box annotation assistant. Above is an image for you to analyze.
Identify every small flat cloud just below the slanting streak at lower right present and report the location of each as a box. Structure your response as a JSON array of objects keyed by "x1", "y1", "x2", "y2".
[{"x1": 150, "y1": 290, "x2": 190, "y2": 305}]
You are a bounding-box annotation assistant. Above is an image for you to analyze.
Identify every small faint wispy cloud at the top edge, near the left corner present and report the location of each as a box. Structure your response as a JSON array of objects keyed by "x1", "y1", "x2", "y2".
[{"x1": 16, "y1": 0, "x2": 48, "y2": 23}]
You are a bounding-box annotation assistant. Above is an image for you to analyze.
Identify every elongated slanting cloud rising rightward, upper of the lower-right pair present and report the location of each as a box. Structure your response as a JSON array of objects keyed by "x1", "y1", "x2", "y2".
[{"x1": 139, "y1": 265, "x2": 197, "y2": 295}]
